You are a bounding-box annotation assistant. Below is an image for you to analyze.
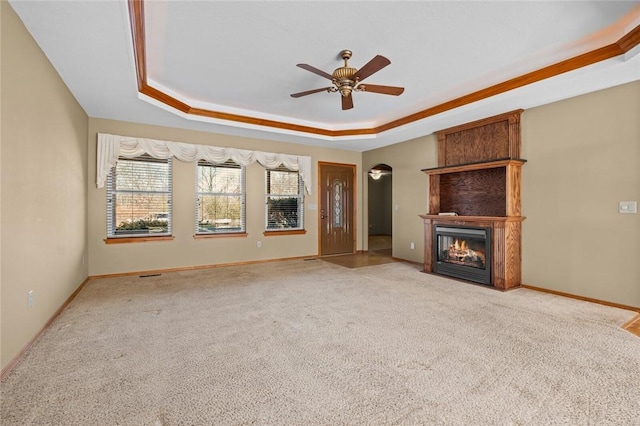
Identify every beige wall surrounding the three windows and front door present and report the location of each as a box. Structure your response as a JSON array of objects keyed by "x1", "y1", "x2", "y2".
[{"x1": 87, "y1": 119, "x2": 366, "y2": 276}]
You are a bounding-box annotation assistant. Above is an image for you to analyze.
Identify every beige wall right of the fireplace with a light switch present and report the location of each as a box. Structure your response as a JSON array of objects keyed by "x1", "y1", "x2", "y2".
[{"x1": 522, "y1": 82, "x2": 640, "y2": 307}]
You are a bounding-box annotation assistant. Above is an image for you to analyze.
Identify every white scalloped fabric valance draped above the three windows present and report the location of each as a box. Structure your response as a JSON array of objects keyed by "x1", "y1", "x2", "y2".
[{"x1": 96, "y1": 133, "x2": 311, "y2": 194}]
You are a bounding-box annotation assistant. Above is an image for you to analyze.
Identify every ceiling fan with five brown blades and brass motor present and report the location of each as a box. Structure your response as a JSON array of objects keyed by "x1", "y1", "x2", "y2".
[{"x1": 291, "y1": 50, "x2": 404, "y2": 110}]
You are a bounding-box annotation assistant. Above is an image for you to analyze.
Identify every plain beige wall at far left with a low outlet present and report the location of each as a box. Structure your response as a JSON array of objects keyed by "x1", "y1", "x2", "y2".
[{"x1": 0, "y1": 1, "x2": 88, "y2": 368}]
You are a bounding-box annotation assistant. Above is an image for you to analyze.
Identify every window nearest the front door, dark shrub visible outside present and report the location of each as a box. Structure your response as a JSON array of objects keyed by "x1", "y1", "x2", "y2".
[{"x1": 266, "y1": 167, "x2": 304, "y2": 231}]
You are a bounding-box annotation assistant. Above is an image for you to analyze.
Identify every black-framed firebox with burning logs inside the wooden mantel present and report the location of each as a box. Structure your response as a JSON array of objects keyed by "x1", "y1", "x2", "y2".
[{"x1": 433, "y1": 225, "x2": 491, "y2": 285}]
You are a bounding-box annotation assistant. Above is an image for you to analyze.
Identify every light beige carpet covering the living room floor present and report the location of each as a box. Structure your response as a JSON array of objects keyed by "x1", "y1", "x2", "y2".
[{"x1": 0, "y1": 260, "x2": 640, "y2": 426}]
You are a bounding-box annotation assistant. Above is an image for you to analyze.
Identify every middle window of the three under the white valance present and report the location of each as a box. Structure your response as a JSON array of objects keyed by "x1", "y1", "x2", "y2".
[{"x1": 196, "y1": 160, "x2": 245, "y2": 235}]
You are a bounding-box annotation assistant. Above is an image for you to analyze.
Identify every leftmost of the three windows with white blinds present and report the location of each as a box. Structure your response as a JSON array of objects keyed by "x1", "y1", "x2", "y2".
[{"x1": 107, "y1": 154, "x2": 172, "y2": 238}]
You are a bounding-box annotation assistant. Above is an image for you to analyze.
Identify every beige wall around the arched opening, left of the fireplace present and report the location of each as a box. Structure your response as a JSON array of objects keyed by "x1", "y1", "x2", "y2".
[{"x1": 362, "y1": 135, "x2": 438, "y2": 263}]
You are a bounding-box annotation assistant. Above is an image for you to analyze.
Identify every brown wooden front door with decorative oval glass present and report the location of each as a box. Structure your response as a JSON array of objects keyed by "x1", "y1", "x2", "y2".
[{"x1": 318, "y1": 163, "x2": 356, "y2": 256}]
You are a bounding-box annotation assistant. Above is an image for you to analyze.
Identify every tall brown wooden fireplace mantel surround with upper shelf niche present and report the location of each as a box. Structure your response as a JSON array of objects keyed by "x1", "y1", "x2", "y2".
[{"x1": 420, "y1": 110, "x2": 526, "y2": 290}]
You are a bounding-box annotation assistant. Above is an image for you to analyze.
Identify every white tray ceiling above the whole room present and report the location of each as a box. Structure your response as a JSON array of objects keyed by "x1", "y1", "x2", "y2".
[{"x1": 10, "y1": 0, "x2": 640, "y2": 151}]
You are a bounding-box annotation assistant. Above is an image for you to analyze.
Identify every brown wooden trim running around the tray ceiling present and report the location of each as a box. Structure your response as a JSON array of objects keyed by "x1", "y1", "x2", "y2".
[{"x1": 128, "y1": 0, "x2": 640, "y2": 137}]
